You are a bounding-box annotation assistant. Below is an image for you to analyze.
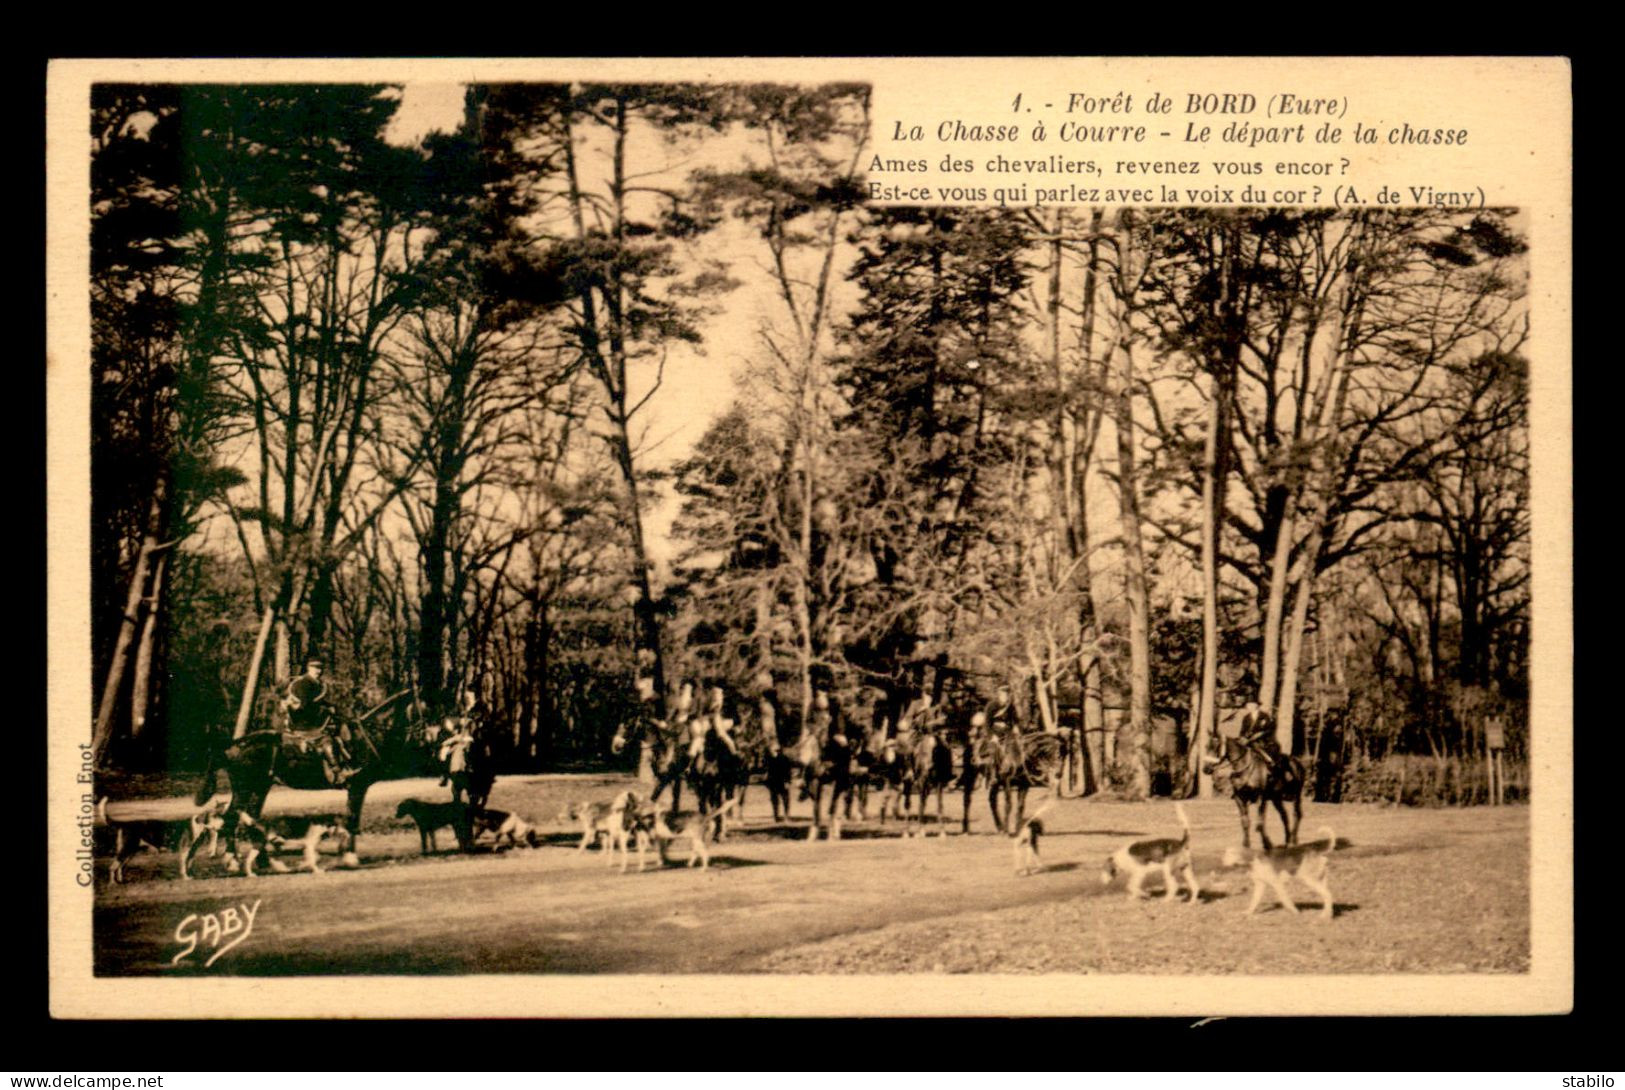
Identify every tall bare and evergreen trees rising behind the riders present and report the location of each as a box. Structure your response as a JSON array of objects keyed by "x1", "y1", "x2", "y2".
[{"x1": 88, "y1": 83, "x2": 1532, "y2": 802}]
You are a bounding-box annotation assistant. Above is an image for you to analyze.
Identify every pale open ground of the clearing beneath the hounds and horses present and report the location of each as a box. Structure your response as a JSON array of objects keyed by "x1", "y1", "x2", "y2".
[{"x1": 94, "y1": 775, "x2": 1529, "y2": 976}]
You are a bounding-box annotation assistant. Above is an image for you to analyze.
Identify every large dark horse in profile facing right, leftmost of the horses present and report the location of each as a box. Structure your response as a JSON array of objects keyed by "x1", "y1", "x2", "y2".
[{"x1": 195, "y1": 694, "x2": 442, "y2": 877}]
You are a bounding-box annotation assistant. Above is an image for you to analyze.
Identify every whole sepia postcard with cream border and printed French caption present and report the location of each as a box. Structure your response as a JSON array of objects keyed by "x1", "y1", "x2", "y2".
[{"x1": 46, "y1": 57, "x2": 1575, "y2": 1019}]
